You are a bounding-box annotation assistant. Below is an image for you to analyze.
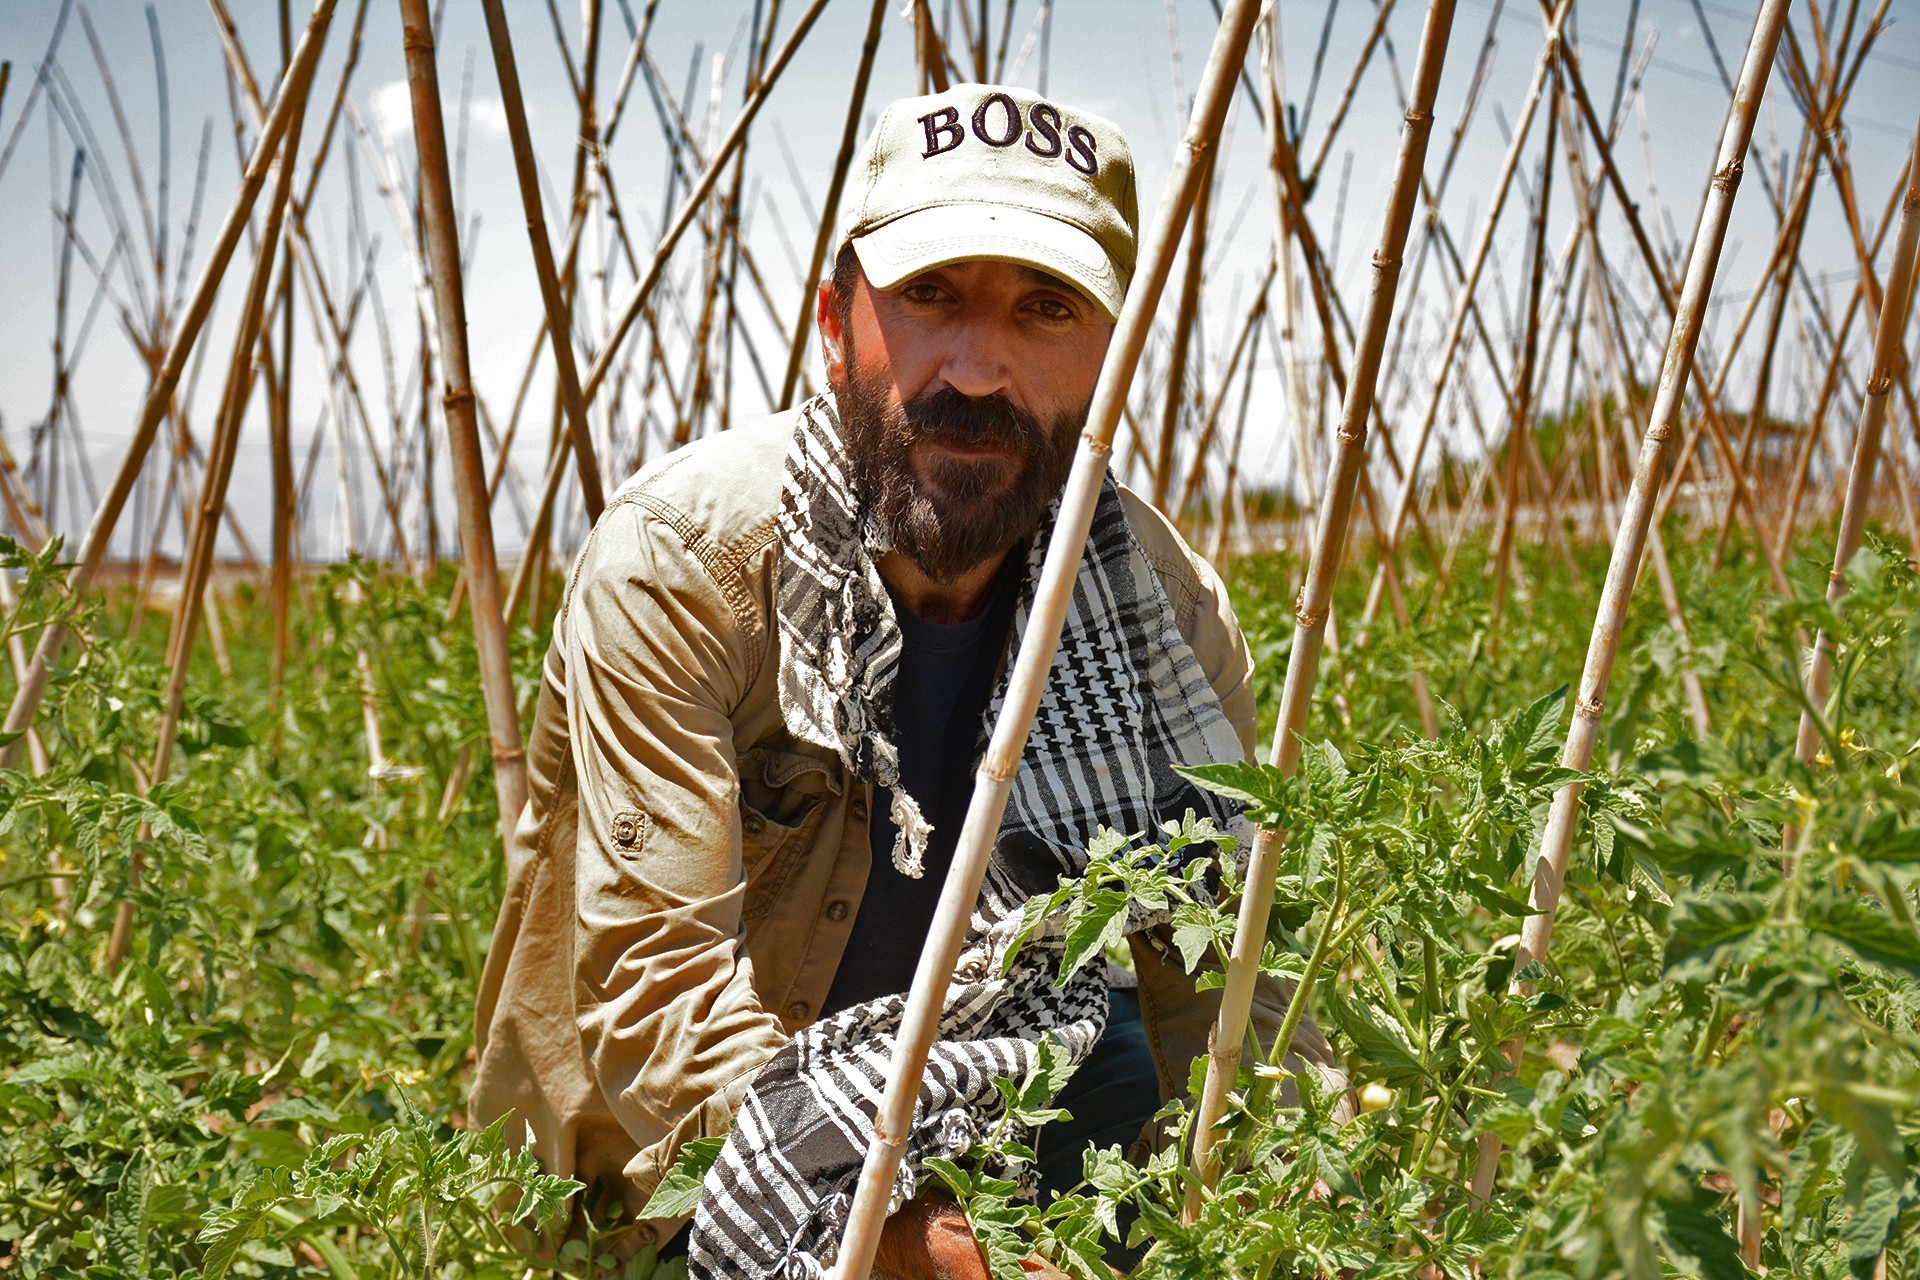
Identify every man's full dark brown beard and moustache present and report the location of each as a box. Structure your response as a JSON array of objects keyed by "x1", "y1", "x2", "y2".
[{"x1": 835, "y1": 351, "x2": 1087, "y2": 583}]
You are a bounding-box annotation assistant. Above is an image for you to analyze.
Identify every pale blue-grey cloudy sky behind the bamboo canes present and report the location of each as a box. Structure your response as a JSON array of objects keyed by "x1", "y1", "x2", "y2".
[{"x1": 0, "y1": 0, "x2": 1920, "y2": 557}]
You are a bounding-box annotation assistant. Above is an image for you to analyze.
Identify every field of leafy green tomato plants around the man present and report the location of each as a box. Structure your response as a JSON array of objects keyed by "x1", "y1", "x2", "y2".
[{"x1": 0, "y1": 521, "x2": 1920, "y2": 1280}]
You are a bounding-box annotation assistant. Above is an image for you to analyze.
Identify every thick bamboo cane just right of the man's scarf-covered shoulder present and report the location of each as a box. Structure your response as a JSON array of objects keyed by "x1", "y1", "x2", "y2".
[{"x1": 1187, "y1": 0, "x2": 1453, "y2": 1219}]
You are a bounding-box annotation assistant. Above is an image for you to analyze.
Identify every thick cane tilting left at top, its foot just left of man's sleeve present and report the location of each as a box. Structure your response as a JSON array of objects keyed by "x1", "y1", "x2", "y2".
[{"x1": 399, "y1": 0, "x2": 529, "y2": 841}]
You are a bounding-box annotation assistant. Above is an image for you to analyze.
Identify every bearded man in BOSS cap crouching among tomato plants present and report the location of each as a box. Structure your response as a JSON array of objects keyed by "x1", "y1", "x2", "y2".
[{"x1": 474, "y1": 84, "x2": 1325, "y2": 1278}]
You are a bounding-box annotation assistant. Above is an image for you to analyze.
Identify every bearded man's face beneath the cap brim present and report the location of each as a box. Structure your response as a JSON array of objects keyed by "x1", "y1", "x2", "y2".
[{"x1": 820, "y1": 261, "x2": 1114, "y2": 581}]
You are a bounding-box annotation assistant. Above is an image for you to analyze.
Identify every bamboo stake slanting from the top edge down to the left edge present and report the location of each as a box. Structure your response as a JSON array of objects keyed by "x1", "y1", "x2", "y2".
[{"x1": 0, "y1": 0, "x2": 338, "y2": 768}]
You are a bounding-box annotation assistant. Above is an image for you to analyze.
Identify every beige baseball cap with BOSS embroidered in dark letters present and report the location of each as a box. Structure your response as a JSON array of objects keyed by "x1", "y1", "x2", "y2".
[{"x1": 841, "y1": 84, "x2": 1139, "y2": 320}]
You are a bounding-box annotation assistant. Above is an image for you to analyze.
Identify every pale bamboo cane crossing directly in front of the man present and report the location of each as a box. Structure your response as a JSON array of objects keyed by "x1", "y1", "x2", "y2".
[{"x1": 833, "y1": 0, "x2": 1274, "y2": 1280}]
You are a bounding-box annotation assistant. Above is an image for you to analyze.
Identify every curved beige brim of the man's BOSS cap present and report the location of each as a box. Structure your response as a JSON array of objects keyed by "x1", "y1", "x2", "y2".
[{"x1": 852, "y1": 203, "x2": 1127, "y2": 320}]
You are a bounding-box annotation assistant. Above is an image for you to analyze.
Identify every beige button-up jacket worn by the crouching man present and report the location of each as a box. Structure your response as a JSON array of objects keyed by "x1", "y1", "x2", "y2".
[{"x1": 472, "y1": 415, "x2": 1325, "y2": 1230}]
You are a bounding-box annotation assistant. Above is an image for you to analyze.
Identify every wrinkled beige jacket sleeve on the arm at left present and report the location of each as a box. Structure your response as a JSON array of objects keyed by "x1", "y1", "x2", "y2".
[{"x1": 564, "y1": 501, "x2": 787, "y2": 1197}]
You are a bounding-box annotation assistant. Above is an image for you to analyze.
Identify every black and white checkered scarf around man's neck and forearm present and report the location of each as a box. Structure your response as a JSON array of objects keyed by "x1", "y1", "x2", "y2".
[{"x1": 689, "y1": 397, "x2": 1242, "y2": 1280}]
